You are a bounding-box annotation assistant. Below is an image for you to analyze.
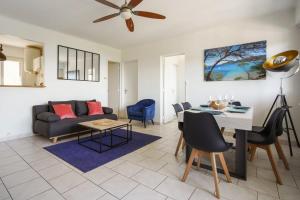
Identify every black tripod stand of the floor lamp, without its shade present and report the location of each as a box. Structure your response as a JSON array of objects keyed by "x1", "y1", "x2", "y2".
[{"x1": 263, "y1": 94, "x2": 300, "y2": 156}]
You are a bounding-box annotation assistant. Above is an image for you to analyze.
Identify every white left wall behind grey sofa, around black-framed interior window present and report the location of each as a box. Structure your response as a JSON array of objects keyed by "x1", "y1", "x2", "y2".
[{"x1": 0, "y1": 16, "x2": 121, "y2": 140}]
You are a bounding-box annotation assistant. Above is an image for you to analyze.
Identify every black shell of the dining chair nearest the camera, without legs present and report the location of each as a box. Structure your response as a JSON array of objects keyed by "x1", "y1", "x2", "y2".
[{"x1": 183, "y1": 111, "x2": 228, "y2": 152}]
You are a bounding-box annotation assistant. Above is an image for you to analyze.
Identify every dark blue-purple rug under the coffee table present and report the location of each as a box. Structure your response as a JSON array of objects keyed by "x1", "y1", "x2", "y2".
[{"x1": 45, "y1": 129, "x2": 161, "y2": 172}]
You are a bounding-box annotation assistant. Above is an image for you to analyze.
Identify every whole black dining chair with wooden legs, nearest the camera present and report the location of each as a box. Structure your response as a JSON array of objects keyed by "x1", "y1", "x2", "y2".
[{"x1": 182, "y1": 112, "x2": 232, "y2": 198}]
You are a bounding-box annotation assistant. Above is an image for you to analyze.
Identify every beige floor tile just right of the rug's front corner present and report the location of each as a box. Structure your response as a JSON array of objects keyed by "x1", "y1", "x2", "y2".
[{"x1": 84, "y1": 167, "x2": 117, "y2": 185}]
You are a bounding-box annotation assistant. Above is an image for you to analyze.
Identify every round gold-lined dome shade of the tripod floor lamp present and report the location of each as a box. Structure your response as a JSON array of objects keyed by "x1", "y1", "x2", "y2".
[{"x1": 263, "y1": 50, "x2": 299, "y2": 72}]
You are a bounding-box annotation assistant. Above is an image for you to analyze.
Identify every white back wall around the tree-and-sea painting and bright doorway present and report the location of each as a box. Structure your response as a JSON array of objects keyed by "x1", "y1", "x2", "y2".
[{"x1": 123, "y1": 10, "x2": 300, "y2": 132}]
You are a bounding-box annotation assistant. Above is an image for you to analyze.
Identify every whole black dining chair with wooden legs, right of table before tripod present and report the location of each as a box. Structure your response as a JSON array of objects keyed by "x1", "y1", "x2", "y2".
[{"x1": 247, "y1": 108, "x2": 289, "y2": 185}]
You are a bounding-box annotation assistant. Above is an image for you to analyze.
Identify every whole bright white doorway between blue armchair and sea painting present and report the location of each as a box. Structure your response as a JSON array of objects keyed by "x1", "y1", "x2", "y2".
[{"x1": 163, "y1": 55, "x2": 186, "y2": 123}]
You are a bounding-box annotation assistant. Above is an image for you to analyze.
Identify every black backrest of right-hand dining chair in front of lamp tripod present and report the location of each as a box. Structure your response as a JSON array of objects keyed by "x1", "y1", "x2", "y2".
[{"x1": 262, "y1": 108, "x2": 285, "y2": 144}]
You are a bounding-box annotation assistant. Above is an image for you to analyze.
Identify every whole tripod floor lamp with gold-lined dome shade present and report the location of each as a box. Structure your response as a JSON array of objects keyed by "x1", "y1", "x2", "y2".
[{"x1": 263, "y1": 50, "x2": 300, "y2": 156}]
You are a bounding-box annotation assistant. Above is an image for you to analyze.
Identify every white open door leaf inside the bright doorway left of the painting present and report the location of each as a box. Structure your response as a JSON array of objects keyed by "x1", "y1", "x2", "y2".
[{"x1": 164, "y1": 62, "x2": 177, "y2": 123}]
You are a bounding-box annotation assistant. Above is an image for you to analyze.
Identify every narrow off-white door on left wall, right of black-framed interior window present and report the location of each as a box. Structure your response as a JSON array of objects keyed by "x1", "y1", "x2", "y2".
[{"x1": 108, "y1": 62, "x2": 120, "y2": 115}]
